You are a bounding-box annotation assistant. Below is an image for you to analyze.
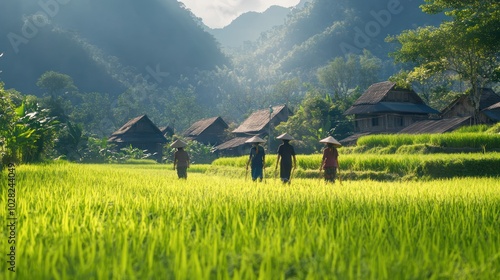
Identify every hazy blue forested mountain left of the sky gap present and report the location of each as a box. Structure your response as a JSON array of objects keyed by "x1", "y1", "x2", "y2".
[{"x1": 0, "y1": 0, "x2": 227, "y2": 94}]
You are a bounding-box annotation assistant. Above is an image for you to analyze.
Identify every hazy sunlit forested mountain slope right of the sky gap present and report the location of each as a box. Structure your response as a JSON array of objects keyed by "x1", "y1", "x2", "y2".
[{"x1": 238, "y1": 0, "x2": 444, "y2": 76}]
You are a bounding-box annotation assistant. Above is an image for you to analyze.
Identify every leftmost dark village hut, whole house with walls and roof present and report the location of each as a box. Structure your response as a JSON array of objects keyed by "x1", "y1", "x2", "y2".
[{"x1": 108, "y1": 115, "x2": 167, "y2": 162}]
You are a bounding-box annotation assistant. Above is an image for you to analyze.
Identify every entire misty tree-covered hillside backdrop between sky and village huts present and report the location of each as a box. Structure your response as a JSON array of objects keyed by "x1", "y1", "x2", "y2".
[{"x1": 0, "y1": 0, "x2": 500, "y2": 166}]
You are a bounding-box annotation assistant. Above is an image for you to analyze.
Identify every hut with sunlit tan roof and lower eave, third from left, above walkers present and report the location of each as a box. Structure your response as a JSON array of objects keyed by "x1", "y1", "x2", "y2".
[{"x1": 215, "y1": 105, "x2": 292, "y2": 156}]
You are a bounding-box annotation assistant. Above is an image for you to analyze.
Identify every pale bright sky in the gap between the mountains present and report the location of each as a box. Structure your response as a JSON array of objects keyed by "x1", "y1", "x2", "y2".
[{"x1": 178, "y1": 0, "x2": 300, "y2": 28}]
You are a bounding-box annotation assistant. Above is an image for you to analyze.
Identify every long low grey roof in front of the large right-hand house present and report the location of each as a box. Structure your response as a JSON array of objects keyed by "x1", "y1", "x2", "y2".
[{"x1": 398, "y1": 117, "x2": 471, "y2": 134}]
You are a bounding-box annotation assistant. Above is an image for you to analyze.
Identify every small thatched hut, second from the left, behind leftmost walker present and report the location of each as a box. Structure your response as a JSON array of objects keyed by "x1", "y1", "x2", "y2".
[{"x1": 183, "y1": 117, "x2": 229, "y2": 145}]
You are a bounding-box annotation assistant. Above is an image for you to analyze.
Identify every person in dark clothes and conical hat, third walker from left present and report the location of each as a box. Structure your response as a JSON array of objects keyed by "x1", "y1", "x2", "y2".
[{"x1": 275, "y1": 133, "x2": 297, "y2": 183}]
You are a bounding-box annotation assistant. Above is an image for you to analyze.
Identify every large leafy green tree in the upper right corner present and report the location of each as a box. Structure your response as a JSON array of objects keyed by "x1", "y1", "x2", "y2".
[{"x1": 387, "y1": 0, "x2": 500, "y2": 122}]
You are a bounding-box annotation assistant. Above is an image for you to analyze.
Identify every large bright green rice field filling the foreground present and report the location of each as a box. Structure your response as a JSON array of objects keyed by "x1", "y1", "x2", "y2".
[{"x1": 0, "y1": 164, "x2": 500, "y2": 279}]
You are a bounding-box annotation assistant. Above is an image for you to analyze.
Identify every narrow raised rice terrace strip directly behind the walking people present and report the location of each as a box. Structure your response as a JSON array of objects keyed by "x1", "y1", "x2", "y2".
[{"x1": 208, "y1": 153, "x2": 500, "y2": 180}]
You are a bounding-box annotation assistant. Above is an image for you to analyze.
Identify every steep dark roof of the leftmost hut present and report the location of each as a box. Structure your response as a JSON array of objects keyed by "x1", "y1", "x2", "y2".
[{"x1": 108, "y1": 115, "x2": 167, "y2": 143}]
